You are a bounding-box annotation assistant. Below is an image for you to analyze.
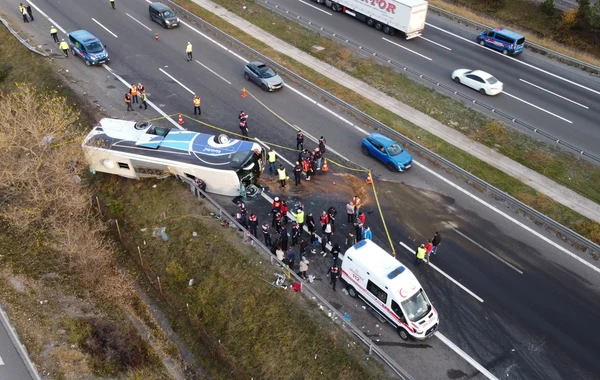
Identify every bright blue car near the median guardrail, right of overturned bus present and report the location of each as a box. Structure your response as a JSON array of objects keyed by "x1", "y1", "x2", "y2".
[{"x1": 362, "y1": 133, "x2": 412, "y2": 172}]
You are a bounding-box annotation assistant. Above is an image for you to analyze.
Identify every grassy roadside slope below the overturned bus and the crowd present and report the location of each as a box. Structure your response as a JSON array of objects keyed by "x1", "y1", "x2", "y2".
[{"x1": 97, "y1": 175, "x2": 386, "y2": 379}]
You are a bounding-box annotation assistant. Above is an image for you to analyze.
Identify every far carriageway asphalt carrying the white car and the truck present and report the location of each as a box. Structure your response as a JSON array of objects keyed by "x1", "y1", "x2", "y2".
[{"x1": 258, "y1": 0, "x2": 600, "y2": 157}]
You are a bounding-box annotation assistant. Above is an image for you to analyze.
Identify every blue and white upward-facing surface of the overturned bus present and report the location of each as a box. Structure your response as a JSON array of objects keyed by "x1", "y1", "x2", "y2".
[{"x1": 83, "y1": 118, "x2": 261, "y2": 170}]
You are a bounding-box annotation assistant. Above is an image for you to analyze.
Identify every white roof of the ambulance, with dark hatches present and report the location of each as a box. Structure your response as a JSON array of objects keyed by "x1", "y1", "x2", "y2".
[{"x1": 344, "y1": 240, "x2": 421, "y2": 299}]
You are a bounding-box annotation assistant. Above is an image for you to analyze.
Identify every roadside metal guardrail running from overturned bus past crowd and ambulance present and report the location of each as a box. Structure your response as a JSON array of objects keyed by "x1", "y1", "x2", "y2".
[{"x1": 177, "y1": 176, "x2": 414, "y2": 380}]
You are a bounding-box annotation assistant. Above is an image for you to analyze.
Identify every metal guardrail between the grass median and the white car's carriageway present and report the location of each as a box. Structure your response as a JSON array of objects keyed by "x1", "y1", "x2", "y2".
[{"x1": 264, "y1": 0, "x2": 600, "y2": 165}]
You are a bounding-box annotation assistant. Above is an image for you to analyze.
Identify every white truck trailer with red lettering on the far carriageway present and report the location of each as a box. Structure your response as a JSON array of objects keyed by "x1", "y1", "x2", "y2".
[{"x1": 313, "y1": 0, "x2": 428, "y2": 40}]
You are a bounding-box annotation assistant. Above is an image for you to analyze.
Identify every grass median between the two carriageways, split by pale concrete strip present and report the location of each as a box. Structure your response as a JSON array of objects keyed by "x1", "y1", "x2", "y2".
[{"x1": 169, "y1": 0, "x2": 600, "y2": 243}]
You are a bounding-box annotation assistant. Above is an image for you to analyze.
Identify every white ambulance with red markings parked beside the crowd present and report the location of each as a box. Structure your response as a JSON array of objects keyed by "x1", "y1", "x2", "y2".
[{"x1": 342, "y1": 240, "x2": 439, "y2": 340}]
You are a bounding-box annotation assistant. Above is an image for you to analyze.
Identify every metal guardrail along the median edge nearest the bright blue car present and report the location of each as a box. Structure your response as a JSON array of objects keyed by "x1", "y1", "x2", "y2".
[{"x1": 167, "y1": 0, "x2": 600, "y2": 264}]
